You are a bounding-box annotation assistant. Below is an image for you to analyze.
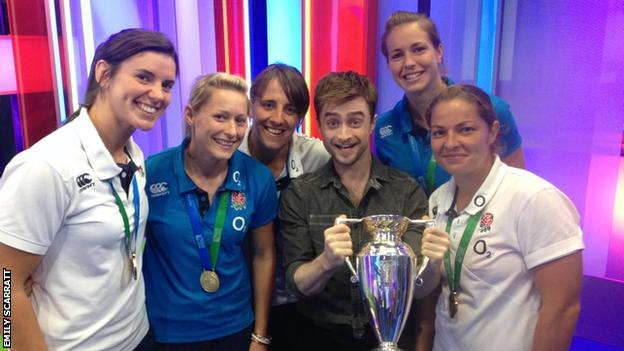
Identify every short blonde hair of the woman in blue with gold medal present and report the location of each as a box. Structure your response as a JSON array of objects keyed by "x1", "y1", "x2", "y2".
[{"x1": 187, "y1": 72, "x2": 250, "y2": 114}]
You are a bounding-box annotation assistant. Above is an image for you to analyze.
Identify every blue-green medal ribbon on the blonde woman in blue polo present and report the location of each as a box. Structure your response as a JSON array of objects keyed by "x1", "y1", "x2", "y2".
[{"x1": 184, "y1": 190, "x2": 230, "y2": 272}]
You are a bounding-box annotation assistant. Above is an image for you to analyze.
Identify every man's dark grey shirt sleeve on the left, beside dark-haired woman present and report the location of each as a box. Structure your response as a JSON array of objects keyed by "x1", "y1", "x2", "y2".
[{"x1": 279, "y1": 180, "x2": 316, "y2": 296}]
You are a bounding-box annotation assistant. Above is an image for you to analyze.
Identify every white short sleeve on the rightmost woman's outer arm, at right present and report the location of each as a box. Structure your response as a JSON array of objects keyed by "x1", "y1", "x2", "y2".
[{"x1": 517, "y1": 188, "x2": 585, "y2": 269}]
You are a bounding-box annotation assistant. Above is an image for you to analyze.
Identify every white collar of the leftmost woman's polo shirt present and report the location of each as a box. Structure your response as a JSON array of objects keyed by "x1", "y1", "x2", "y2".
[{"x1": 75, "y1": 107, "x2": 144, "y2": 181}]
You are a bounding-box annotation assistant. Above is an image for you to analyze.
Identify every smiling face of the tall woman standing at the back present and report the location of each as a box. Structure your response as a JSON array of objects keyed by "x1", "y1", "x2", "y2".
[{"x1": 385, "y1": 22, "x2": 444, "y2": 95}]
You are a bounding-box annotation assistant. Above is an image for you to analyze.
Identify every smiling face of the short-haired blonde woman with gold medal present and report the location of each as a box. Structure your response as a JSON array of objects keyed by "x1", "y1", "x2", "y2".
[{"x1": 184, "y1": 89, "x2": 248, "y2": 160}]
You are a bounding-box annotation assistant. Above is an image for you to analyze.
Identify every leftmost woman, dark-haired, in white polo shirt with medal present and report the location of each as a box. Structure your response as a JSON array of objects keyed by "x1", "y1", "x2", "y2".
[{"x1": 0, "y1": 29, "x2": 178, "y2": 350}]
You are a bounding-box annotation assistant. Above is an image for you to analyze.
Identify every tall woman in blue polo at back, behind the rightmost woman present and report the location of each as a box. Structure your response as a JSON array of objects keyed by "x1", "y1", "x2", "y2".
[{"x1": 375, "y1": 11, "x2": 524, "y2": 194}]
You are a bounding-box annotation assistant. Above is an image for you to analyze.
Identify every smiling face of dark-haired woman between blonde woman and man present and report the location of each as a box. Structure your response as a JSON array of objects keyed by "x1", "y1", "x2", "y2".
[{"x1": 250, "y1": 78, "x2": 299, "y2": 153}]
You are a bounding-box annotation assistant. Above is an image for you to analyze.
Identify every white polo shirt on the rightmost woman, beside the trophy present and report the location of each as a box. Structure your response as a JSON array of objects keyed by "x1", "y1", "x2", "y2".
[{"x1": 429, "y1": 157, "x2": 584, "y2": 351}]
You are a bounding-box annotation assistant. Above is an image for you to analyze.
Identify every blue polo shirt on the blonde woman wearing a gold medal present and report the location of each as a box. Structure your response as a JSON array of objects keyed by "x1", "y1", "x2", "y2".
[{"x1": 143, "y1": 139, "x2": 277, "y2": 343}]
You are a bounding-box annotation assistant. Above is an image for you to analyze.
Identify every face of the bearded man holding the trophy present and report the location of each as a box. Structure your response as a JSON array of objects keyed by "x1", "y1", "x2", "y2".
[{"x1": 319, "y1": 97, "x2": 374, "y2": 166}]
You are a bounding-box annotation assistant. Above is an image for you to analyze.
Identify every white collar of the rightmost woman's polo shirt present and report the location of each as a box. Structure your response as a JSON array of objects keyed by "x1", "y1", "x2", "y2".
[{"x1": 443, "y1": 155, "x2": 508, "y2": 215}]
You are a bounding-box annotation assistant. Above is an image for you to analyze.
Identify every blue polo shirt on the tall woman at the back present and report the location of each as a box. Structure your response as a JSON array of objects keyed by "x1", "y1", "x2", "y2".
[{"x1": 375, "y1": 80, "x2": 522, "y2": 195}]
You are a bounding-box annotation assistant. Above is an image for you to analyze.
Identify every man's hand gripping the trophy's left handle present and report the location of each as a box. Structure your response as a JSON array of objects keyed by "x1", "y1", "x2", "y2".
[{"x1": 322, "y1": 215, "x2": 353, "y2": 270}]
